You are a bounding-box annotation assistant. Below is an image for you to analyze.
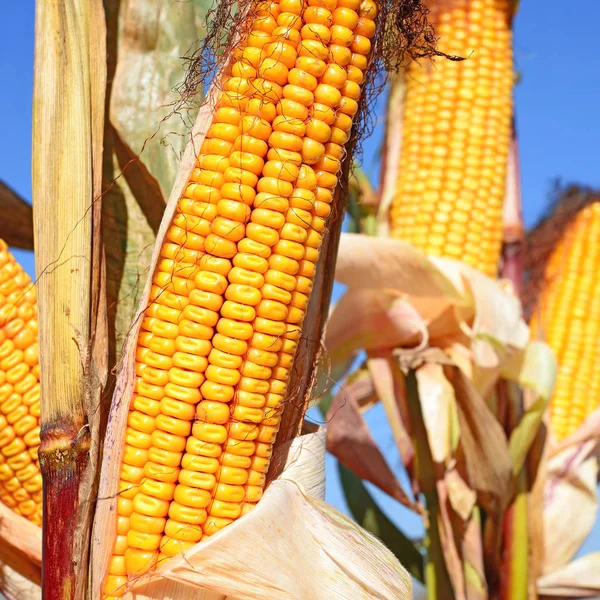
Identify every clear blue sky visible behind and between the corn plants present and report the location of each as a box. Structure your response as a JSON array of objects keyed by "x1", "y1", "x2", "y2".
[{"x1": 0, "y1": 0, "x2": 600, "y2": 553}]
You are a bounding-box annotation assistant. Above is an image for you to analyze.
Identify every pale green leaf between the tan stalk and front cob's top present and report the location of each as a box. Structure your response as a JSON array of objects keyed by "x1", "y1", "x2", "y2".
[{"x1": 110, "y1": 0, "x2": 210, "y2": 197}]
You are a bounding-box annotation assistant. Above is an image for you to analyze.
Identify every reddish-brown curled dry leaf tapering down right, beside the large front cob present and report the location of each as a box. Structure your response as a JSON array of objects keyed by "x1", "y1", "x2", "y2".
[{"x1": 327, "y1": 383, "x2": 423, "y2": 514}]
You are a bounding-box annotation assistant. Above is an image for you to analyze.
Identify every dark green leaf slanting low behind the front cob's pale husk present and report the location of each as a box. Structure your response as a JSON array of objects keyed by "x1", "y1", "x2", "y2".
[{"x1": 338, "y1": 464, "x2": 425, "y2": 581}]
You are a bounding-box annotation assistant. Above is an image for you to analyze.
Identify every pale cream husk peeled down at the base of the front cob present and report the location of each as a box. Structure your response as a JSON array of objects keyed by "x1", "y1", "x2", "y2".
[{"x1": 124, "y1": 432, "x2": 412, "y2": 600}]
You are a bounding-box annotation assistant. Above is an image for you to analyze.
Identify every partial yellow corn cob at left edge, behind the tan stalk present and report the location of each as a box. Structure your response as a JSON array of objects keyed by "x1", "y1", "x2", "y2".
[{"x1": 0, "y1": 240, "x2": 42, "y2": 525}]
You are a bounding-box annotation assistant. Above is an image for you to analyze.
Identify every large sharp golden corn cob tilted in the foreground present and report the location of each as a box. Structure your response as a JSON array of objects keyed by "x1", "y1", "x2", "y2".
[{"x1": 104, "y1": 0, "x2": 377, "y2": 597}]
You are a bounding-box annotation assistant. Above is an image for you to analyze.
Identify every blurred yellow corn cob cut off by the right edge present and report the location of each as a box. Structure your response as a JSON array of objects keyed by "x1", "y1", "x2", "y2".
[{"x1": 531, "y1": 201, "x2": 600, "y2": 441}]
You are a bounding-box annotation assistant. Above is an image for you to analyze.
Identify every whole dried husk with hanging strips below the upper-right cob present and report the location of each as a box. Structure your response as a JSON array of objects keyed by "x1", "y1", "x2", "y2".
[{"x1": 325, "y1": 234, "x2": 556, "y2": 599}]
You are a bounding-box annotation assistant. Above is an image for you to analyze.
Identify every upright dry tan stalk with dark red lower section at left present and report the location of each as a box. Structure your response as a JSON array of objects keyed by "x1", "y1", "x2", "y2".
[{"x1": 33, "y1": 0, "x2": 108, "y2": 600}]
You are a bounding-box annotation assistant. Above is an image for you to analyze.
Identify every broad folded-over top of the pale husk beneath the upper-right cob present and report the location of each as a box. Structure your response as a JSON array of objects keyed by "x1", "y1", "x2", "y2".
[{"x1": 325, "y1": 234, "x2": 529, "y2": 385}]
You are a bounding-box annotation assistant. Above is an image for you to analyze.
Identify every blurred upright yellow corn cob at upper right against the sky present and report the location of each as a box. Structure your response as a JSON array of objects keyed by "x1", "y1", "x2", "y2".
[{"x1": 390, "y1": 0, "x2": 513, "y2": 276}]
